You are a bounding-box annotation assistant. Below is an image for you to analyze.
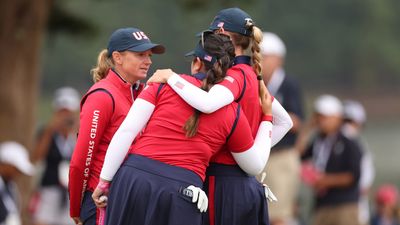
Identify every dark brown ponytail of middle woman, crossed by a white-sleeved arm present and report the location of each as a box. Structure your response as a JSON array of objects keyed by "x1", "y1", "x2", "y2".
[{"x1": 183, "y1": 34, "x2": 235, "y2": 137}]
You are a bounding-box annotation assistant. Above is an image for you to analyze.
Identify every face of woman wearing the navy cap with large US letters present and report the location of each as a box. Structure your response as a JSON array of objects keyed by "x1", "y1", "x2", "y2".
[{"x1": 113, "y1": 50, "x2": 152, "y2": 84}]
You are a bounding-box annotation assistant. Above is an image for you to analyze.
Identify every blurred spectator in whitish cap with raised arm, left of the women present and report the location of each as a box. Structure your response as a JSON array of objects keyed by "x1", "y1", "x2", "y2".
[{"x1": 33, "y1": 87, "x2": 80, "y2": 225}]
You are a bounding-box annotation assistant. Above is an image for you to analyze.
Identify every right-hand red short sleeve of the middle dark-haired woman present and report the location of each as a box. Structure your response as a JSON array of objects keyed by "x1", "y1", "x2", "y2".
[{"x1": 226, "y1": 106, "x2": 254, "y2": 152}]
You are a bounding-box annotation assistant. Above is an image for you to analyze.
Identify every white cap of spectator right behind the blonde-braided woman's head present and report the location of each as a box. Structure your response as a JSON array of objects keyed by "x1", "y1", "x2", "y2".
[{"x1": 260, "y1": 32, "x2": 286, "y2": 58}]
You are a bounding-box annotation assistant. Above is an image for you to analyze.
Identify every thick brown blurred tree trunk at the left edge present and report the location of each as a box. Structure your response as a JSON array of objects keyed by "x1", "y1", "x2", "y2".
[{"x1": 0, "y1": 0, "x2": 52, "y2": 224}]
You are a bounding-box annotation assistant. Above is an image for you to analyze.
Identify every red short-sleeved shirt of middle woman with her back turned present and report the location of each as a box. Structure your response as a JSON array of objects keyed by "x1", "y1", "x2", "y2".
[{"x1": 130, "y1": 75, "x2": 254, "y2": 180}]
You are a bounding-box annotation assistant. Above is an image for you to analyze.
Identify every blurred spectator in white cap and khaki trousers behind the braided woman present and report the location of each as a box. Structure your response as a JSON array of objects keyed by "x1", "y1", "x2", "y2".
[{"x1": 260, "y1": 33, "x2": 303, "y2": 225}]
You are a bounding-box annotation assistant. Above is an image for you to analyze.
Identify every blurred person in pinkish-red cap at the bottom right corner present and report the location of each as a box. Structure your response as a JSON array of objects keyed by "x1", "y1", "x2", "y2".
[{"x1": 371, "y1": 184, "x2": 400, "y2": 225}]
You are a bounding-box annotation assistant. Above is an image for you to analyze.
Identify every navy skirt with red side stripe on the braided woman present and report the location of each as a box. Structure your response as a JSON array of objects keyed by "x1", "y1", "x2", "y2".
[{"x1": 203, "y1": 163, "x2": 269, "y2": 225}]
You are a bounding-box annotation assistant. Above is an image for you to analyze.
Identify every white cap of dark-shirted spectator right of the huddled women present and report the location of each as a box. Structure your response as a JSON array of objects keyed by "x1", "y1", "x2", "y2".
[{"x1": 314, "y1": 95, "x2": 343, "y2": 116}]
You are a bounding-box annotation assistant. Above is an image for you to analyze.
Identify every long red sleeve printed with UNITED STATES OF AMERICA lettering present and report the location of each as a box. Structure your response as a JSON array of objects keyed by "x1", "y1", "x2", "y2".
[{"x1": 68, "y1": 91, "x2": 113, "y2": 217}]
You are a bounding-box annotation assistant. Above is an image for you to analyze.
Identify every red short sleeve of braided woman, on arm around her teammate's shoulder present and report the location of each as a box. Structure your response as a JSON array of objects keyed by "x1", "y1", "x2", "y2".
[{"x1": 218, "y1": 68, "x2": 244, "y2": 100}]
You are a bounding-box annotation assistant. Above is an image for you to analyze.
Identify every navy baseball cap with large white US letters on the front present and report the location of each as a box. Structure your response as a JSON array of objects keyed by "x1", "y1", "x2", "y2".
[{"x1": 107, "y1": 27, "x2": 165, "y2": 57}]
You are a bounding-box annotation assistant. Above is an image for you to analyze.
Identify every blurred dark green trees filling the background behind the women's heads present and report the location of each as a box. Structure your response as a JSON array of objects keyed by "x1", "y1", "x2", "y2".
[{"x1": 42, "y1": 0, "x2": 400, "y2": 94}]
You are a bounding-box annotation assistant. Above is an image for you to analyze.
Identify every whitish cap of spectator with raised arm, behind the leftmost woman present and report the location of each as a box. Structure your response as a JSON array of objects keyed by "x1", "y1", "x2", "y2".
[{"x1": 53, "y1": 87, "x2": 81, "y2": 111}]
